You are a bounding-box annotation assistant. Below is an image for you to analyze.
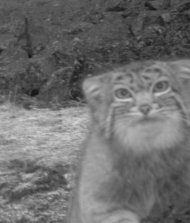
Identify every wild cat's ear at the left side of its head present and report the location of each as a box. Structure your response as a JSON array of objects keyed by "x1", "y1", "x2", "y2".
[{"x1": 82, "y1": 75, "x2": 104, "y2": 108}]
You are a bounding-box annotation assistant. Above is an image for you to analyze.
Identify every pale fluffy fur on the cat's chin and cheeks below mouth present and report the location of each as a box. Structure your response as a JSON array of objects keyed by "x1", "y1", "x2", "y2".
[{"x1": 113, "y1": 111, "x2": 185, "y2": 152}]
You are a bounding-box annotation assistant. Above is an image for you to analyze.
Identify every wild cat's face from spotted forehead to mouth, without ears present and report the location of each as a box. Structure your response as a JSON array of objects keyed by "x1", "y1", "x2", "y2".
[{"x1": 111, "y1": 62, "x2": 180, "y2": 123}]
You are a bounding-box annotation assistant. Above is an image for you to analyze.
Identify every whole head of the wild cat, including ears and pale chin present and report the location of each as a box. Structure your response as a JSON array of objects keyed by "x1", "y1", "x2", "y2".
[{"x1": 83, "y1": 60, "x2": 190, "y2": 151}]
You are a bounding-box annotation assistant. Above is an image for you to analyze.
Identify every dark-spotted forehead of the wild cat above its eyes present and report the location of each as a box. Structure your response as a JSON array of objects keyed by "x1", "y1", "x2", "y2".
[{"x1": 112, "y1": 64, "x2": 169, "y2": 89}]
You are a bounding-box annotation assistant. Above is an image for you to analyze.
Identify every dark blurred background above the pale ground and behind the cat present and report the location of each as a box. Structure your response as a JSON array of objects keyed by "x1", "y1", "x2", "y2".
[{"x1": 0, "y1": 0, "x2": 190, "y2": 109}]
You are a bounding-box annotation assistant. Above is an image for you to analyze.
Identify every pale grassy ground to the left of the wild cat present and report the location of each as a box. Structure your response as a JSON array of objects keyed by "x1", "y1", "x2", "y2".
[{"x1": 0, "y1": 105, "x2": 87, "y2": 223}]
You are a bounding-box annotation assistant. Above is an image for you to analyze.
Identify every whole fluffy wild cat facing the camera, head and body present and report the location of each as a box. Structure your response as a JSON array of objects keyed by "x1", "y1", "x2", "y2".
[{"x1": 68, "y1": 61, "x2": 190, "y2": 223}]
